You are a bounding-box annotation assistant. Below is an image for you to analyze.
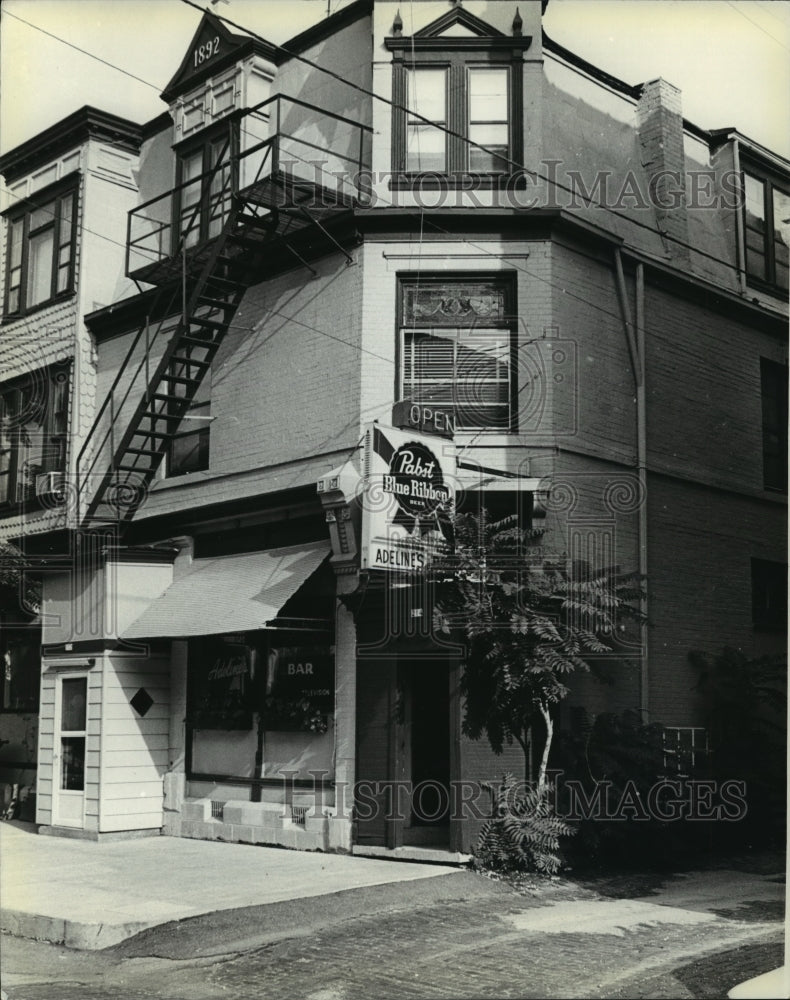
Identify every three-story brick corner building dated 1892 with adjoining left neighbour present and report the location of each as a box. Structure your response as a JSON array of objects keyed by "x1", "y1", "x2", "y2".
[{"x1": 0, "y1": 0, "x2": 790, "y2": 854}]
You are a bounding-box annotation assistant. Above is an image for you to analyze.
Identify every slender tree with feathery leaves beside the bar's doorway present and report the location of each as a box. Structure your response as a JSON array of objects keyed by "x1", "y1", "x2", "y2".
[{"x1": 433, "y1": 509, "x2": 642, "y2": 798}]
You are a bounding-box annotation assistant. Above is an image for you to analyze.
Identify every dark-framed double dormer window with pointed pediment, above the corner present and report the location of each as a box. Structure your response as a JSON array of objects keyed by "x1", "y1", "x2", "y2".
[{"x1": 385, "y1": 7, "x2": 530, "y2": 178}]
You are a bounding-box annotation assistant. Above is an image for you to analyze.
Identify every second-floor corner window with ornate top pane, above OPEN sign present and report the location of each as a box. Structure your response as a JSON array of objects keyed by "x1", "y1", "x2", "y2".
[{"x1": 398, "y1": 278, "x2": 516, "y2": 430}]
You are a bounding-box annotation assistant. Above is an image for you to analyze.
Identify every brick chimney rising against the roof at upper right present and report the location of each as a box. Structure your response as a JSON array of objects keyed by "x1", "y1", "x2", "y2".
[{"x1": 636, "y1": 78, "x2": 689, "y2": 263}]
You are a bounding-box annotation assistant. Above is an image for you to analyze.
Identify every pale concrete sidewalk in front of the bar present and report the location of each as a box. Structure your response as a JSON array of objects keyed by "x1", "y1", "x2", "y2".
[{"x1": 0, "y1": 823, "x2": 458, "y2": 950}]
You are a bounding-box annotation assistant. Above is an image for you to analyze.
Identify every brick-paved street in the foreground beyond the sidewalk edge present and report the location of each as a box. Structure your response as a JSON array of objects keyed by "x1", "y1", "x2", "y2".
[{"x1": 2, "y1": 816, "x2": 785, "y2": 1000}]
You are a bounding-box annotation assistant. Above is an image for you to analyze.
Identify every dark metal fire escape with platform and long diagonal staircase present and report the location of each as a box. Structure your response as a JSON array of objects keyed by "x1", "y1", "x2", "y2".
[{"x1": 76, "y1": 95, "x2": 371, "y2": 528}]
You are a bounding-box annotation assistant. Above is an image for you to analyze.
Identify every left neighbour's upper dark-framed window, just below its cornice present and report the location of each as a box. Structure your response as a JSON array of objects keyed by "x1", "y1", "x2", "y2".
[{"x1": 5, "y1": 182, "x2": 77, "y2": 316}]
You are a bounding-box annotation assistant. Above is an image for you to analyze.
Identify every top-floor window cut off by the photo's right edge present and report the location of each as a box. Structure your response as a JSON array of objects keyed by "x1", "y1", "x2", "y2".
[{"x1": 743, "y1": 173, "x2": 790, "y2": 291}]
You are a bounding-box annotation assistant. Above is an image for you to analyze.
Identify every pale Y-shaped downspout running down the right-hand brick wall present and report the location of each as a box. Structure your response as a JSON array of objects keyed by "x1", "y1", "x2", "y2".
[{"x1": 614, "y1": 247, "x2": 650, "y2": 722}]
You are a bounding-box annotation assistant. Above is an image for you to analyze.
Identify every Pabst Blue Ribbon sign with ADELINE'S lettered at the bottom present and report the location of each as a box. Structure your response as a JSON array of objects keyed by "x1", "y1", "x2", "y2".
[{"x1": 362, "y1": 424, "x2": 455, "y2": 573}]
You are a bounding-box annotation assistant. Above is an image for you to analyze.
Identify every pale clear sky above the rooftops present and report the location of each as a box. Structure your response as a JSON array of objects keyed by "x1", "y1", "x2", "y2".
[{"x1": 0, "y1": 0, "x2": 790, "y2": 158}]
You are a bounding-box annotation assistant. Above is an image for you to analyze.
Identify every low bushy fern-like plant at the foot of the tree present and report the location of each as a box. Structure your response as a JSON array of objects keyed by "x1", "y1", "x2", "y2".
[{"x1": 475, "y1": 773, "x2": 574, "y2": 875}]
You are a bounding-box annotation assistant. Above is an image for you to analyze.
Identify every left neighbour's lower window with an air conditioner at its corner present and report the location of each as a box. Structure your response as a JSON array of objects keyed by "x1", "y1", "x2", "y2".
[{"x1": 0, "y1": 364, "x2": 69, "y2": 506}]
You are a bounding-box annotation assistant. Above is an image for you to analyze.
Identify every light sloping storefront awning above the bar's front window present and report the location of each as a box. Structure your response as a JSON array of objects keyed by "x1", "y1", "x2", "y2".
[{"x1": 122, "y1": 542, "x2": 330, "y2": 639}]
